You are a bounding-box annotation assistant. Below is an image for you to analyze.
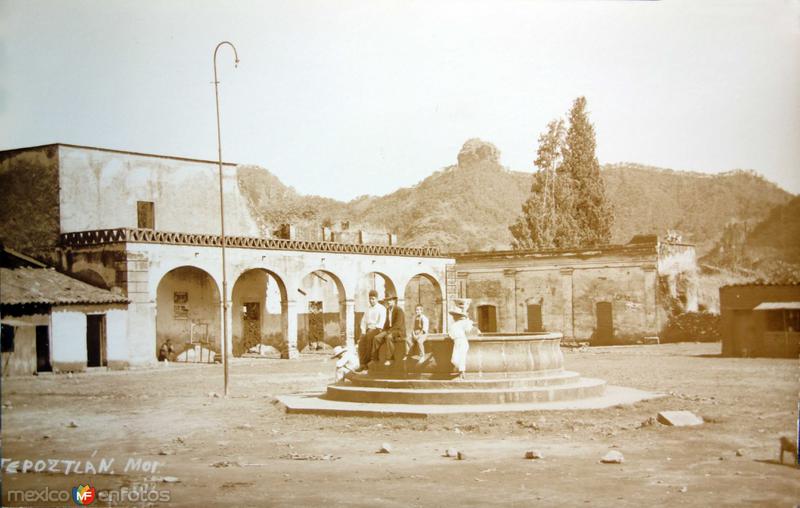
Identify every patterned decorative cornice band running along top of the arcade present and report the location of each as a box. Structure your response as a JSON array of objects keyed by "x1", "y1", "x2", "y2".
[{"x1": 61, "y1": 228, "x2": 445, "y2": 257}]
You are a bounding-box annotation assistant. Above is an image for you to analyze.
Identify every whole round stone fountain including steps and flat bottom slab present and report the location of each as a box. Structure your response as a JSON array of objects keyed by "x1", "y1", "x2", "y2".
[{"x1": 278, "y1": 333, "x2": 658, "y2": 416}]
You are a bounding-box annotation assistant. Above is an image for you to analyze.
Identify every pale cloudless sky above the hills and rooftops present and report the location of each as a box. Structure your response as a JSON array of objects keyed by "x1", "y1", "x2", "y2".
[{"x1": 0, "y1": 0, "x2": 800, "y2": 200}]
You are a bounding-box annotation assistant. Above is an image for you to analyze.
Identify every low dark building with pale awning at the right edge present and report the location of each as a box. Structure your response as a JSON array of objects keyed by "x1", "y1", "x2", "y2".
[{"x1": 719, "y1": 284, "x2": 800, "y2": 358}]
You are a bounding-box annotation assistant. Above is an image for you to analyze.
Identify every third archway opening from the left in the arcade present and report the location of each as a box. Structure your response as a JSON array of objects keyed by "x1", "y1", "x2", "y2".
[{"x1": 297, "y1": 270, "x2": 347, "y2": 351}]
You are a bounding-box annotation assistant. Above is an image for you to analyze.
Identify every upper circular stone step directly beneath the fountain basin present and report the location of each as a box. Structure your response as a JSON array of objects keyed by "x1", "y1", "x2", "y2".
[{"x1": 343, "y1": 371, "x2": 580, "y2": 390}]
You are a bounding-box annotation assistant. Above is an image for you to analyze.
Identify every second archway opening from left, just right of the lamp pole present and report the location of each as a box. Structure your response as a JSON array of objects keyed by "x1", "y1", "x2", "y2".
[{"x1": 231, "y1": 268, "x2": 288, "y2": 356}]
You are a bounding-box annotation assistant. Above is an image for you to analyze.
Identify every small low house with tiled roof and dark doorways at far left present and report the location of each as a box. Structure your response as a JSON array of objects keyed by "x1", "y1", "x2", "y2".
[{"x1": 0, "y1": 248, "x2": 128, "y2": 376}]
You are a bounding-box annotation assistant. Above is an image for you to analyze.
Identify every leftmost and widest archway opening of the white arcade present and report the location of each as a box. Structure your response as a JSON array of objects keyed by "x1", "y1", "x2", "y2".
[{"x1": 154, "y1": 265, "x2": 221, "y2": 361}]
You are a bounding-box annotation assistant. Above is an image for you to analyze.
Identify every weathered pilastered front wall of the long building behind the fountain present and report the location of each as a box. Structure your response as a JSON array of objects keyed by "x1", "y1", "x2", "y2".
[{"x1": 456, "y1": 243, "x2": 661, "y2": 344}]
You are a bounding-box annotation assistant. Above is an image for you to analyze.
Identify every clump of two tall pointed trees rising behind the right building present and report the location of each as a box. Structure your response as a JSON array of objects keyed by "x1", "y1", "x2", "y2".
[{"x1": 509, "y1": 97, "x2": 613, "y2": 249}]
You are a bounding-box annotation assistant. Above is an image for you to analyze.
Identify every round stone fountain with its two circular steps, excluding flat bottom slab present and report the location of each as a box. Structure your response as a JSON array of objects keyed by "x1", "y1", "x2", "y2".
[{"x1": 324, "y1": 333, "x2": 605, "y2": 404}]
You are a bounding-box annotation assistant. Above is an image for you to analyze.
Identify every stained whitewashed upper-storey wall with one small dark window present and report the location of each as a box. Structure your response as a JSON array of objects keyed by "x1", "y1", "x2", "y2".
[{"x1": 59, "y1": 146, "x2": 260, "y2": 236}]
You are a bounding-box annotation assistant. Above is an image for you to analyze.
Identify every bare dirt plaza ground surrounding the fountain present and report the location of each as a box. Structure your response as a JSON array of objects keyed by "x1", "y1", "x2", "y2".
[{"x1": 2, "y1": 343, "x2": 800, "y2": 507}]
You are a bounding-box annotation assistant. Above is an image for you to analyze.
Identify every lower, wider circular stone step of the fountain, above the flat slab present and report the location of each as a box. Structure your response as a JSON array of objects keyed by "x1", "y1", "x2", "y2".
[{"x1": 324, "y1": 378, "x2": 606, "y2": 404}]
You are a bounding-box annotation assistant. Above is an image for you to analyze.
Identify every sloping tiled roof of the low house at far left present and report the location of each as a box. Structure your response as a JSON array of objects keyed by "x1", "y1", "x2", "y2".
[{"x1": 0, "y1": 267, "x2": 128, "y2": 305}]
